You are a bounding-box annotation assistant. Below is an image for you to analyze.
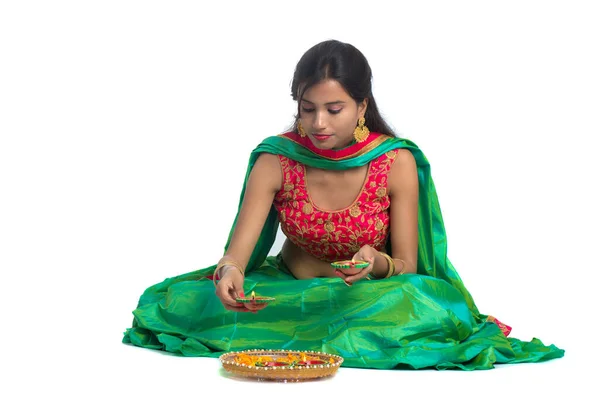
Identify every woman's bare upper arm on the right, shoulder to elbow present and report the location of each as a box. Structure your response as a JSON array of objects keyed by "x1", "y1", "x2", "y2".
[{"x1": 384, "y1": 149, "x2": 419, "y2": 274}]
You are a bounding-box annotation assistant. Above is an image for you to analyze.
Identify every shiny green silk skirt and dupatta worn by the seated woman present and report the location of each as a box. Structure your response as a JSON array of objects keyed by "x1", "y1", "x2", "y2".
[{"x1": 123, "y1": 136, "x2": 564, "y2": 370}]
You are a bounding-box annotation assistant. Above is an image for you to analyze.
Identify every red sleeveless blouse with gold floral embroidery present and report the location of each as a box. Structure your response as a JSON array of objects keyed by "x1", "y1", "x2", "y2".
[{"x1": 274, "y1": 150, "x2": 398, "y2": 262}]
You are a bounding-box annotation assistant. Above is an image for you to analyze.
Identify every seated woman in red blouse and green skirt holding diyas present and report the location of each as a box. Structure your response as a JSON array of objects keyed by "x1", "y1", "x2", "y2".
[{"x1": 123, "y1": 41, "x2": 564, "y2": 370}]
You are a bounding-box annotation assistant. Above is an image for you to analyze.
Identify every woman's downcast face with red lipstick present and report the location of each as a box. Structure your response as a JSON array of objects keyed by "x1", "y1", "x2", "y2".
[{"x1": 299, "y1": 79, "x2": 367, "y2": 149}]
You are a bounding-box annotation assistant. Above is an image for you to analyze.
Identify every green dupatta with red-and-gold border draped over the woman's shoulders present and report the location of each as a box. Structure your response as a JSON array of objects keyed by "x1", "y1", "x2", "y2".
[{"x1": 225, "y1": 133, "x2": 487, "y2": 319}]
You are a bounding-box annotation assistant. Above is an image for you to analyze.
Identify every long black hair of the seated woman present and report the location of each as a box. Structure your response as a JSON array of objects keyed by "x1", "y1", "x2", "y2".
[{"x1": 292, "y1": 40, "x2": 396, "y2": 136}]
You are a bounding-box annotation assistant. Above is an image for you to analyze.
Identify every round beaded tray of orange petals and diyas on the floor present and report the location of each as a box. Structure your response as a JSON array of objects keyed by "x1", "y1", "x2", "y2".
[{"x1": 219, "y1": 350, "x2": 344, "y2": 381}]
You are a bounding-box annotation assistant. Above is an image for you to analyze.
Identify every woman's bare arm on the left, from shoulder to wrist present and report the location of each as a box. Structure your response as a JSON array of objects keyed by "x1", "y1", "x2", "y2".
[{"x1": 222, "y1": 153, "x2": 283, "y2": 272}]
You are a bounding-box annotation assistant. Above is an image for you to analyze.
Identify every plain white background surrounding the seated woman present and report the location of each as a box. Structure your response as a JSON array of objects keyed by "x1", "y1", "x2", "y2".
[{"x1": 0, "y1": 0, "x2": 600, "y2": 399}]
